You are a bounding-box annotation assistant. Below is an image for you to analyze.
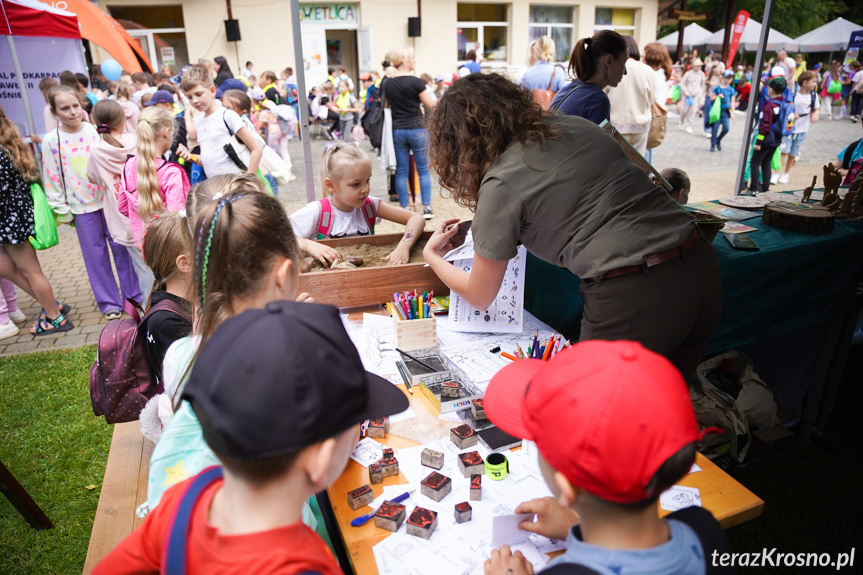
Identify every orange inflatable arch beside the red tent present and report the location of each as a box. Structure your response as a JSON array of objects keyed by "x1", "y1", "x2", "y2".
[{"x1": 43, "y1": 0, "x2": 153, "y2": 73}]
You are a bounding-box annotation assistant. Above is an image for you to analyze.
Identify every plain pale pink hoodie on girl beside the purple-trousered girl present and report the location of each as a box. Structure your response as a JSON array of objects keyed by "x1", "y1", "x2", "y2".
[{"x1": 87, "y1": 134, "x2": 137, "y2": 247}]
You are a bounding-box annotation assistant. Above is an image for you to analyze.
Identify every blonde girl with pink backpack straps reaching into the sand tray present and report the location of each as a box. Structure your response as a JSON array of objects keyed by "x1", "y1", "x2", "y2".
[{"x1": 291, "y1": 142, "x2": 425, "y2": 265}]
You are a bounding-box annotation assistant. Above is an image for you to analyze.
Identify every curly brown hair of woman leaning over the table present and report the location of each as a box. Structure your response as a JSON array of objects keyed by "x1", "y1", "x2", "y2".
[{"x1": 428, "y1": 73, "x2": 557, "y2": 210}]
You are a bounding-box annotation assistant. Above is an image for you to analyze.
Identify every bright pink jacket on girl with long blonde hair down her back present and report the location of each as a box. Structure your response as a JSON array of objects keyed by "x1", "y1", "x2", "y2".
[{"x1": 118, "y1": 156, "x2": 191, "y2": 250}]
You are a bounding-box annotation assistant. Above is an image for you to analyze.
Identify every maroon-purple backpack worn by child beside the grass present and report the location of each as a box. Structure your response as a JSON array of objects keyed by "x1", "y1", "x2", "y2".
[{"x1": 90, "y1": 299, "x2": 189, "y2": 423}]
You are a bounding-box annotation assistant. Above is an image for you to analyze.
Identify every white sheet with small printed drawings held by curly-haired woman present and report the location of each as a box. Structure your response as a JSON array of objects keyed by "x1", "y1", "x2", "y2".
[{"x1": 449, "y1": 246, "x2": 527, "y2": 333}]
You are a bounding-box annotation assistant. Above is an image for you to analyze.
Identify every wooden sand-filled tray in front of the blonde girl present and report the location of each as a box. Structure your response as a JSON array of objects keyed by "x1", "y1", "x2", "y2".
[{"x1": 299, "y1": 232, "x2": 449, "y2": 310}]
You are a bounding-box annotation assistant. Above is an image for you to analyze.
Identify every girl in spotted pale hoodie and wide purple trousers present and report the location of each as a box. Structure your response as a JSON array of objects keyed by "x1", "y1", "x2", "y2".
[{"x1": 42, "y1": 86, "x2": 141, "y2": 319}]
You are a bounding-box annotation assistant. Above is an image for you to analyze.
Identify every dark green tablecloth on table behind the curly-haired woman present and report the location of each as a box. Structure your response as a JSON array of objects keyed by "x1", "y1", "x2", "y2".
[{"x1": 525, "y1": 212, "x2": 863, "y2": 354}]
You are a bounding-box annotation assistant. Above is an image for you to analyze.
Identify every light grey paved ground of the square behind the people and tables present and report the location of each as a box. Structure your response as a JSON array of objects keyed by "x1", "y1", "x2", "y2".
[{"x1": 0, "y1": 113, "x2": 863, "y2": 356}]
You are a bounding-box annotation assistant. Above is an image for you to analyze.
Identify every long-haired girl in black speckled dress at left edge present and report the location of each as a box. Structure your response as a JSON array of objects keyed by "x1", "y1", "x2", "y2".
[{"x1": 0, "y1": 107, "x2": 67, "y2": 339}]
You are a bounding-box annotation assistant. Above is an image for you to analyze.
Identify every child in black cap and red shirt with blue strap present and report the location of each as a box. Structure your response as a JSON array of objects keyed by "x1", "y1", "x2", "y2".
[{"x1": 93, "y1": 302, "x2": 408, "y2": 575}]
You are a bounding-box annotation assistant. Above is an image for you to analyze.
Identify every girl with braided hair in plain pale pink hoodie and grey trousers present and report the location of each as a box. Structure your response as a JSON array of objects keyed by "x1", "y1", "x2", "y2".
[{"x1": 87, "y1": 100, "x2": 153, "y2": 300}]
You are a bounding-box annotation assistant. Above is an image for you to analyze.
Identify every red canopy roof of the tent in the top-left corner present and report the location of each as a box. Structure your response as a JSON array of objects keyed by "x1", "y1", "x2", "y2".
[{"x1": 0, "y1": 0, "x2": 81, "y2": 40}]
